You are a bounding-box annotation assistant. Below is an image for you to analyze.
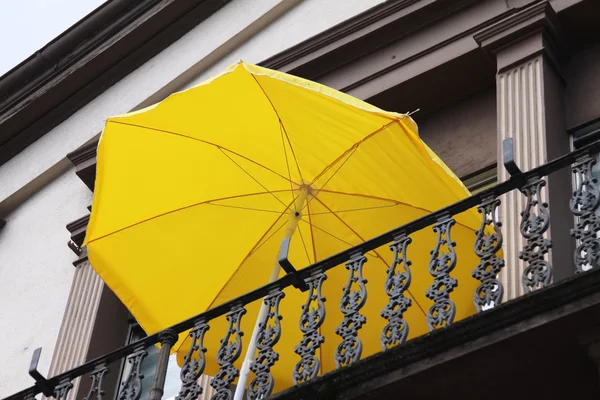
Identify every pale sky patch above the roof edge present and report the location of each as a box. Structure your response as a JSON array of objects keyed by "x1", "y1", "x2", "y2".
[{"x1": 0, "y1": 0, "x2": 105, "y2": 76}]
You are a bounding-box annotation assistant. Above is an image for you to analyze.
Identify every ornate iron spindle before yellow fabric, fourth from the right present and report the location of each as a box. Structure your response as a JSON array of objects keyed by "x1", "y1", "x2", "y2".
[{"x1": 425, "y1": 215, "x2": 458, "y2": 331}]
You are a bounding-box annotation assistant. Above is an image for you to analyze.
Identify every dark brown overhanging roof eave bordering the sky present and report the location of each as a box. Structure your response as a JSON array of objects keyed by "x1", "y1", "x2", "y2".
[{"x1": 0, "y1": 0, "x2": 230, "y2": 165}]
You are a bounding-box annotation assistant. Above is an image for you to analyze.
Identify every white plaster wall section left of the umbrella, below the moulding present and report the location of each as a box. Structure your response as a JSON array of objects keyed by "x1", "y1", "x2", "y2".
[{"x1": 0, "y1": 170, "x2": 92, "y2": 398}]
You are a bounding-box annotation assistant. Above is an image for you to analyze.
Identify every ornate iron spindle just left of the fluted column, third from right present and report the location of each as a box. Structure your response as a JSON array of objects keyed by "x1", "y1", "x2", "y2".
[{"x1": 472, "y1": 196, "x2": 504, "y2": 312}]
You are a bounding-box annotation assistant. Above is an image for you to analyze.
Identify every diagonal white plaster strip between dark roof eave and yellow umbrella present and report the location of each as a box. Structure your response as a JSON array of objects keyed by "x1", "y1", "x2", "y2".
[{"x1": 0, "y1": 0, "x2": 383, "y2": 203}]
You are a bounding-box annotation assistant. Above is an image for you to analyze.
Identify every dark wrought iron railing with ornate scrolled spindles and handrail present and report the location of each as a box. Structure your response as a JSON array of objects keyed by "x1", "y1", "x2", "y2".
[{"x1": 8, "y1": 139, "x2": 600, "y2": 400}]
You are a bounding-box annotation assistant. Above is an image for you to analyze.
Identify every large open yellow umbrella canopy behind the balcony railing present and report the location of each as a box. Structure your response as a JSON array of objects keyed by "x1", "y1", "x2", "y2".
[{"x1": 86, "y1": 62, "x2": 480, "y2": 396}]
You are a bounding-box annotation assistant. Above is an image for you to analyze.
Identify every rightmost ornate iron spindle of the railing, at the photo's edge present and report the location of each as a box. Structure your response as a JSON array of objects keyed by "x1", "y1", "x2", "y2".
[{"x1": 569, "y1": 154, "x2": 600, "y2": 272}]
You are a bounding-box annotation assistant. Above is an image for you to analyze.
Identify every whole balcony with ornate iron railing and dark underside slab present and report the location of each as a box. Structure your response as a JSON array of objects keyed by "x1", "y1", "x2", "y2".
[{"x1": 8, "y1": 141, "x2": 600, "y2": 400}]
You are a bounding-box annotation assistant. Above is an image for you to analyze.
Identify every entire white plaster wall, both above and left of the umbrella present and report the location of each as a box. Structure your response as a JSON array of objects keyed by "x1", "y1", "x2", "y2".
[{"x1": 0, "y1": 0, "x2": 383, "y2": 398}]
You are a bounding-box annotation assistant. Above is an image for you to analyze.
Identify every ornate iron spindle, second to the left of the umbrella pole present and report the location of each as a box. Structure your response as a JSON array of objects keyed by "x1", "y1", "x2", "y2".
[{"x1": 175, "y1": 319, "x2": 210, "y2": 400}]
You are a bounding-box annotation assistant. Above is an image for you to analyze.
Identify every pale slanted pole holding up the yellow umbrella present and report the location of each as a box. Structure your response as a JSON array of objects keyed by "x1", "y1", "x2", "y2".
[{"x1": 233, "y1": 187, "x2": 308, "y2": 400}]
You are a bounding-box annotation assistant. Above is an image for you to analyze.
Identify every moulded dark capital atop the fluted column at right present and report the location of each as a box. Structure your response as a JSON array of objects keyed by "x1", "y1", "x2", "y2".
[{"x1": 473, "y1": 0, "x2": 568, "y2": 73}]
